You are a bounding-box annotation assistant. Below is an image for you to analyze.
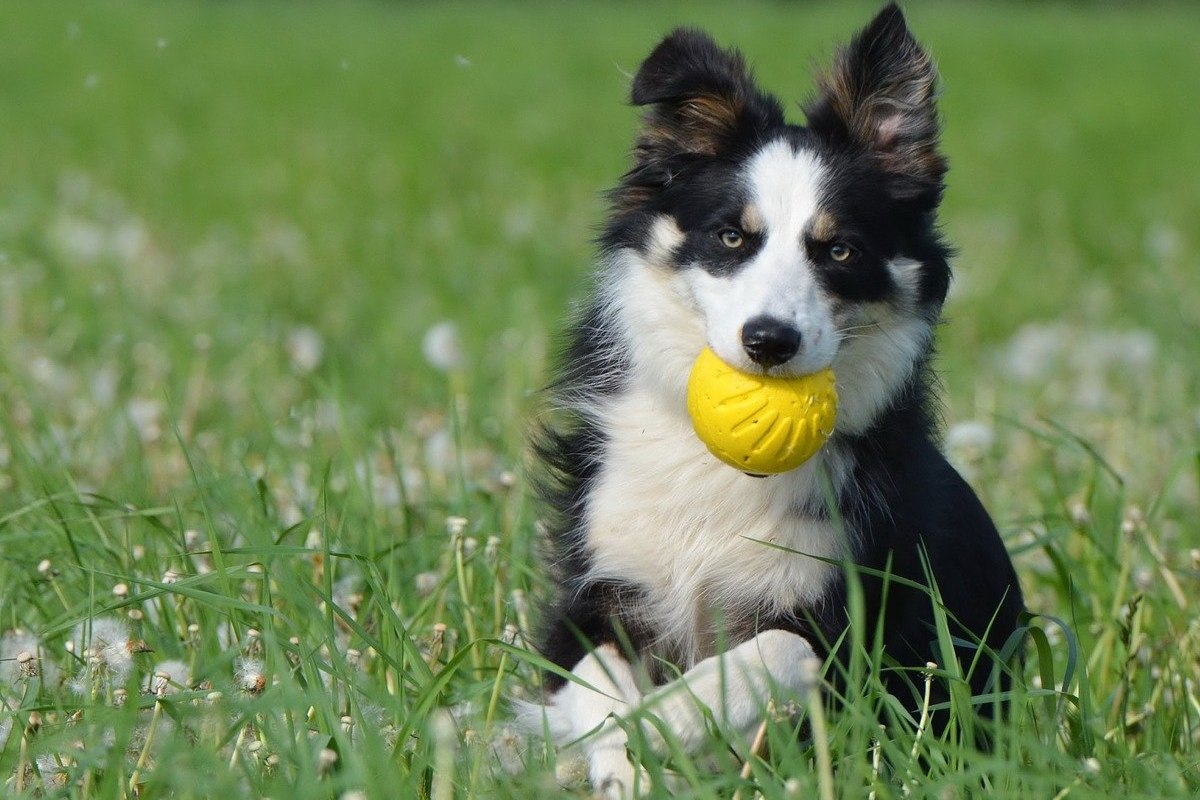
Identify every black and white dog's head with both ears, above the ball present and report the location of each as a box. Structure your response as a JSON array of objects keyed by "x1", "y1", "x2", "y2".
[{"x1": 604, "y1": 5, "x2": 949, "y2": 431}]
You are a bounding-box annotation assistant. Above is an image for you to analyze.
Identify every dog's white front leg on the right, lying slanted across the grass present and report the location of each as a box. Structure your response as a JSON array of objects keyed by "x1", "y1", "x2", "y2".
[{"x1": 642, "y1": 630, "x2": 820, "y2": 753}]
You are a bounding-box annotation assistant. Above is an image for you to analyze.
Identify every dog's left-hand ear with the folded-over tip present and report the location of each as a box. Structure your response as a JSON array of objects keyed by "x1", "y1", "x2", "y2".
[{"x1": 632, "y1": 28, "x2": 784, "y2": 167}]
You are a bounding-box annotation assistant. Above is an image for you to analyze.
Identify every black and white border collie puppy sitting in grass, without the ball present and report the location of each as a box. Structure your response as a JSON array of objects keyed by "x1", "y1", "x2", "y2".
[{"x1": 526, "y1": 5, "x2": 1022, "y2": 795}]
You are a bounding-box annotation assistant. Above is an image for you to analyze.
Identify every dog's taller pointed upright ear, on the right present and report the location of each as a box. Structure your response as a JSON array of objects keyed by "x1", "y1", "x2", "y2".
[{"x1": 804, "y1": 4, "x2": 946, "y2": 199}]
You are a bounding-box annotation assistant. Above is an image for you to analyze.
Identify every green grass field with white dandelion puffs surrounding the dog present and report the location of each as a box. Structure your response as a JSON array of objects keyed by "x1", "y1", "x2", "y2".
[{"x1": 0, "y1": 0, "x2": 1200, "y2": 800}]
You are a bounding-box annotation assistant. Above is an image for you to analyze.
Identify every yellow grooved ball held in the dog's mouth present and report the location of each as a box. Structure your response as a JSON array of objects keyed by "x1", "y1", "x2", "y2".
[{"x1": 688, "y1": 348, "x2": 838, "y2": 475}]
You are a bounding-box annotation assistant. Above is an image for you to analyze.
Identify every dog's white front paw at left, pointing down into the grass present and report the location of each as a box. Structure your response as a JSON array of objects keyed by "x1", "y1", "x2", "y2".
[{"x1": 530, "y1": 644, "x2": 644, "y2": 799}]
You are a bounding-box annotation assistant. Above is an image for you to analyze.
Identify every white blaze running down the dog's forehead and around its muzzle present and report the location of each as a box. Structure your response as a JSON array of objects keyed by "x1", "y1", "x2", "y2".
[{"x1": 685, "y1": 140, "x2": 838, "y2": 374}]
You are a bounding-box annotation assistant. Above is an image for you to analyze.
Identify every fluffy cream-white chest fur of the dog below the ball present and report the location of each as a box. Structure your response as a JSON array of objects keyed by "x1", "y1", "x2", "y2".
[{"x1": 587, "y1": 391, "x2": 847, "y2": 667}]
